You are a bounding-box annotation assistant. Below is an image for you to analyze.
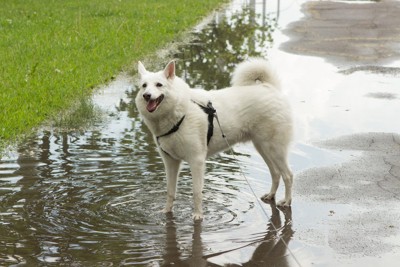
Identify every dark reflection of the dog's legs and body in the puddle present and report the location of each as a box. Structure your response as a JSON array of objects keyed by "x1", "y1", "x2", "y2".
[{"x1": 162, "y1": 201, "x2": 294, "y2": 267}]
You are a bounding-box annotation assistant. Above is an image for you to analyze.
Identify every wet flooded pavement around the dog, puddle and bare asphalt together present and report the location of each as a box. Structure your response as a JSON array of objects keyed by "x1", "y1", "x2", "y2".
[{"x1": 0, "y1": 1, "x2": 400, "y2": 267}]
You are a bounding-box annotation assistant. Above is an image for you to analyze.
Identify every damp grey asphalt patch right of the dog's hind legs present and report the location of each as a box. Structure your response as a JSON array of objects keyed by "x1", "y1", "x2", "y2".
[{"x1": 296, "y1": 133, "x2": 400, "y2": 258}]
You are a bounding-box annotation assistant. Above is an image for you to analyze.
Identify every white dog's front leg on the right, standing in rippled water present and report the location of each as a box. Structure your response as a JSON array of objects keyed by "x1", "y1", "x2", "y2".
[{"x1": 189, "y1": 159, "x2": 206, "y2": 221}]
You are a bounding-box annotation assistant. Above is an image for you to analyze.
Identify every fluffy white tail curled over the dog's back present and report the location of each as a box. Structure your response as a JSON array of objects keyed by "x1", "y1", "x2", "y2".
[{"x1": 231, "y1": 58, "x2": 280, "y2": 88}]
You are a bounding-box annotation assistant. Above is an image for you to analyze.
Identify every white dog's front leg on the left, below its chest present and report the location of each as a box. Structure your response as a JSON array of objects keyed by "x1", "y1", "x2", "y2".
[{"x1": 161, "y1": 153, "x2": 181, "y2": 213}]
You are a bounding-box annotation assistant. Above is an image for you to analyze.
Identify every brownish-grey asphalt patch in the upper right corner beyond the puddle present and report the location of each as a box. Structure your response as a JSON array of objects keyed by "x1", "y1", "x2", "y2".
[{"x1": 284, "y1": 0, "x2": 400, "y2": 64}]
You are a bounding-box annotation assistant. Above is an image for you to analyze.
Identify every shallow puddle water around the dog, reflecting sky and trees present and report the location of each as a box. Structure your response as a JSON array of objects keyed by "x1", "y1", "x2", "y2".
[{"x1": 0, "y1": 1, "x2": 400, "y2": 266}]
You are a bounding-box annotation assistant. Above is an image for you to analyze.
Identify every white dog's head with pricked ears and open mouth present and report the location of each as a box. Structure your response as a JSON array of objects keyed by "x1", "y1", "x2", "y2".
[{"x1": 136, "y1": 61, "x2": 175, "y2": 115}]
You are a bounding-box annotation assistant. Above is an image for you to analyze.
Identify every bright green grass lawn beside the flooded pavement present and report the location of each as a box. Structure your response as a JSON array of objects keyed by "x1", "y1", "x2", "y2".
[{"x1": 0, "y1": 0, "x2": 226, "y2": 142}]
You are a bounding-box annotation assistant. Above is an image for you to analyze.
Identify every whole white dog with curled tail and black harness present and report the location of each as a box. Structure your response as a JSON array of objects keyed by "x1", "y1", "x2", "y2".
[{"x1": 135, "y1": 59, "x2": 293, "y2": 220}]
